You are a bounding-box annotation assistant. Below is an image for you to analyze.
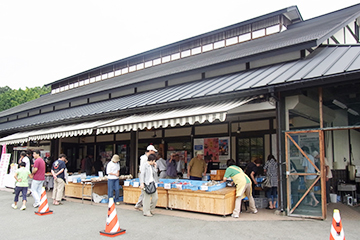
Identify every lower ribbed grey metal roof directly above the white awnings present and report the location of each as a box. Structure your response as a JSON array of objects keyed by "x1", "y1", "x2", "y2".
[{"x1": 0, "y1": 45, "x2": 360, "y2": 132}]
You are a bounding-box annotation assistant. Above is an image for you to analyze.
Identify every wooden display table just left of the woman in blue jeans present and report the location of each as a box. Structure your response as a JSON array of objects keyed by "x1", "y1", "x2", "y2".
[{"x1": 65, "y1": 181, "x2": 108, "y2": 200}]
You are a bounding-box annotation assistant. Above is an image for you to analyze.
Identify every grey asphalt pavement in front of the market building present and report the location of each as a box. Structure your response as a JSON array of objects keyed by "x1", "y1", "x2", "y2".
[{"x1": 0, "y1": 190, "x2": 360, "y2": 240}]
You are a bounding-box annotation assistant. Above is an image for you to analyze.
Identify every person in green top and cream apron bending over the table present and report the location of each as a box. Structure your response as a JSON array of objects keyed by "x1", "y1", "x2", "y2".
[{"x1": 221, "y1": 159, "x2": 257, "y2": 218}]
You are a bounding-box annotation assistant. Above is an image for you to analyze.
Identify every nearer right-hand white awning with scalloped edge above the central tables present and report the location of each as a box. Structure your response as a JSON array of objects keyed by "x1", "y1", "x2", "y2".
[{"x1": 96, "y1": 98, "x2": 252, "y2": 134}]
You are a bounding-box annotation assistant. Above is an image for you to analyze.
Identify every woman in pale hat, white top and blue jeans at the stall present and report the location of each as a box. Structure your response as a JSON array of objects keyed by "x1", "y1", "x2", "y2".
[{"x1": 106, "y1": 154, "x2": 120, "y2": 205}]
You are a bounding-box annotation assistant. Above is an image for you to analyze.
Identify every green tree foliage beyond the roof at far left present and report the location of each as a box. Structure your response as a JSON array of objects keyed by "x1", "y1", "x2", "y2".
[{"x1": 0, "y1": 86, "x2": 51, "y2": 112}]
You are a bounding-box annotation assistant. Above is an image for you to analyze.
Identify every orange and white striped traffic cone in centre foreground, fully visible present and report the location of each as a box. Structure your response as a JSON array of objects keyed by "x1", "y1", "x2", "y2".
[{"x1": 100, "y1": 198, "x2": 126, "y2": 237}]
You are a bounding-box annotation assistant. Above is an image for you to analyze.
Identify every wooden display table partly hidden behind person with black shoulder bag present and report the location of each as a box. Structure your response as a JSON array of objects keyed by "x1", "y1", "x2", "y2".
[{"x1": 123, "y1": 186, "x2": 168, "y2": 208}]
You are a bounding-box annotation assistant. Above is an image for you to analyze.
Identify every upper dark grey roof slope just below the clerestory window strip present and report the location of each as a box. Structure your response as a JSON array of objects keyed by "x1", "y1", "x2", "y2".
[{"x1": 0, "y1": 4, "x2": 360, "y2": 120}]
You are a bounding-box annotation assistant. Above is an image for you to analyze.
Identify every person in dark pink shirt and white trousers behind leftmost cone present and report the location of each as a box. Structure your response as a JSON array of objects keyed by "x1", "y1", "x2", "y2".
[{"x1": 31, "y1": 150, "x2": 45, "y2": 208}]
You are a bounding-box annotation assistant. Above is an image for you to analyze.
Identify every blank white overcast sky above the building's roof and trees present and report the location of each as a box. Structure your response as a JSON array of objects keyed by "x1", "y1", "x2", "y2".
[{"x1": 0, "y1": 0, "x2": 358, "y2": 89}]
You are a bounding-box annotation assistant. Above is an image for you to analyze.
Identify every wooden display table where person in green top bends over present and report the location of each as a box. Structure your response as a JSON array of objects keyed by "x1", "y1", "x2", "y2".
[{"x1": 168, "y1": 188, "x2": 235, "y2": 216}]
